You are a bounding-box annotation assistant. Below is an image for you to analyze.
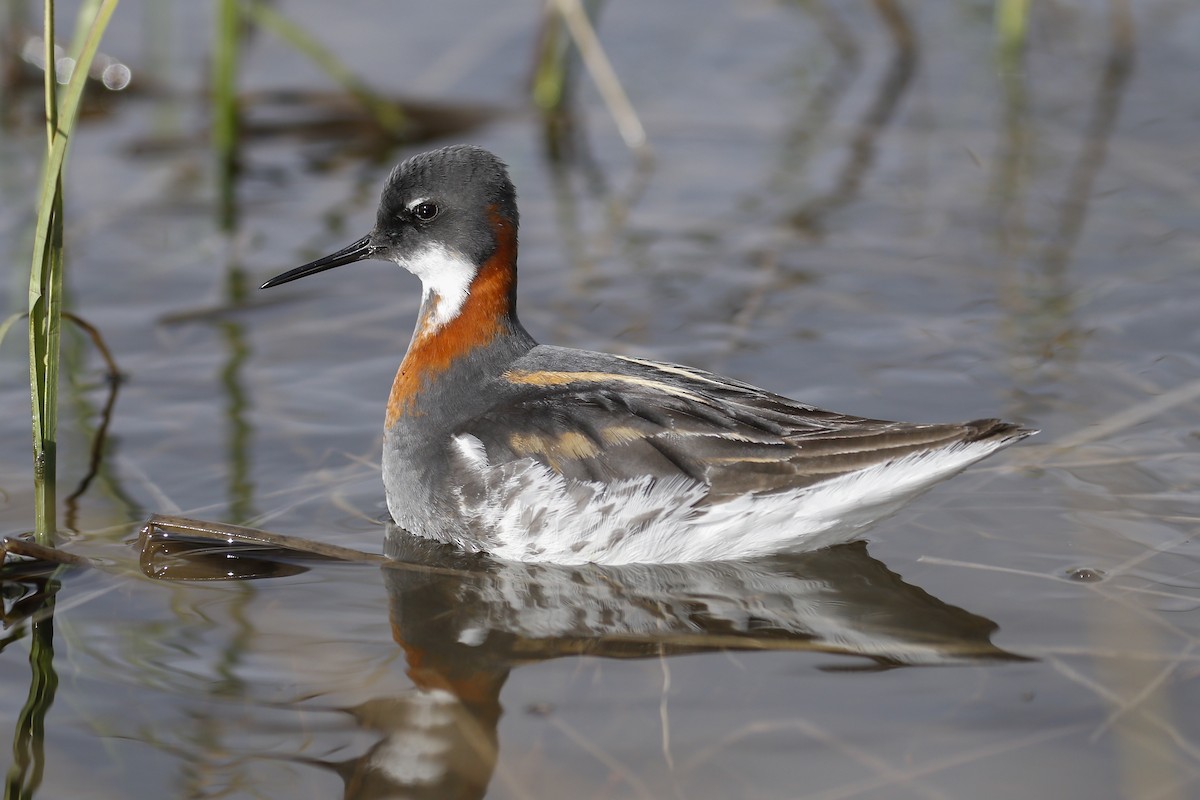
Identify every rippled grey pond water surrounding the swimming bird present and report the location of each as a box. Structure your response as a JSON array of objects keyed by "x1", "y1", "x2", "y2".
[{"x1": 0, "y1": 0, "x2": 1200, "y2": 800}]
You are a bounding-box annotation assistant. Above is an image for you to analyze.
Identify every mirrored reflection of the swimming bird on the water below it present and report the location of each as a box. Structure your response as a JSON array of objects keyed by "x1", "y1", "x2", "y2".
[{"x1": 143, "y1": 530, "x2": 1024, "y2": 800}]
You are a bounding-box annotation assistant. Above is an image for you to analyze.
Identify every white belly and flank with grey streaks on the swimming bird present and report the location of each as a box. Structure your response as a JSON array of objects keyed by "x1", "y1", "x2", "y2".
[{"x1": 436, "y1": 435, "x2": 1000, "y2": 564}]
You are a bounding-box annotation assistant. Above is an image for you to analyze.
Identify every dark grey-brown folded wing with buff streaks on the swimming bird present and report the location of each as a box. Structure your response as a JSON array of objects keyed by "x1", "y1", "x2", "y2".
[{"x1": 457, "y1": 366, "x2": 1024, "y2": 501}]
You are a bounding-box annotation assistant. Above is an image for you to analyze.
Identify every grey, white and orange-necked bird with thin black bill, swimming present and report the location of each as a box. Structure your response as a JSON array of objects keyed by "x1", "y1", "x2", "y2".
[{"x1": 263, "y1": 145, "x2": 1034, "y2": 564}]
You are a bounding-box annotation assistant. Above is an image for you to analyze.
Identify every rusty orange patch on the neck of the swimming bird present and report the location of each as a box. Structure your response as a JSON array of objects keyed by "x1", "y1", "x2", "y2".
[{"x1": 386, "y1": 207, "x2": 517, "y2": 428}]
